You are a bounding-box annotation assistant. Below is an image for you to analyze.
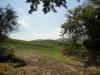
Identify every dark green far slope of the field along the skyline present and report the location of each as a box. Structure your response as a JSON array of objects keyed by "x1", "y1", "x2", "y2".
[{"x1": 4, "y1": 39, "x2": 62, "y2": 50}]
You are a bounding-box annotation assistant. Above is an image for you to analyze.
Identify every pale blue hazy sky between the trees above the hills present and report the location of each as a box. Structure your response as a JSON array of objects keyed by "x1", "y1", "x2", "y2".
[{"x1": 0, "y1": 0, "x2": 85, "y2": 41}]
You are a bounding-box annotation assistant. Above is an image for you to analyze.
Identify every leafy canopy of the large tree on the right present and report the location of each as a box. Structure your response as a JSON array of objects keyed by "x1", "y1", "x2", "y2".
[{"x1": 62, "y1": 0, "x2": 100, "y2": 43}]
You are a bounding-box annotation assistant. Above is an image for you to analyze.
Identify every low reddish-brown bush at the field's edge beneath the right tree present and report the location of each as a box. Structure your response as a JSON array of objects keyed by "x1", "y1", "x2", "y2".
[{"x1": 61, "y1": 47, "x2": 89, "y2": 62}]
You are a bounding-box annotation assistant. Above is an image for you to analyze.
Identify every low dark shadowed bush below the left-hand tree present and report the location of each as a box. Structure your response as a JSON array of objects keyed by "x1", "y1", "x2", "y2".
[{"x1": 0, "y1": 47, "x2": 26, "y2": 67}]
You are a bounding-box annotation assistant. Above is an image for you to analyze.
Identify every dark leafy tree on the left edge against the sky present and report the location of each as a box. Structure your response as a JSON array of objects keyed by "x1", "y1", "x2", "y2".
[{"x1": 0, "y1": 5, "x2": 18, "y2": 44}]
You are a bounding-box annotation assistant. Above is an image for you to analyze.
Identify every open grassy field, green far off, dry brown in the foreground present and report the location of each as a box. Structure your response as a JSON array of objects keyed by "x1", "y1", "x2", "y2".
[{"x1": 0, "y1": 39, "x2": 100, "y2": 75}]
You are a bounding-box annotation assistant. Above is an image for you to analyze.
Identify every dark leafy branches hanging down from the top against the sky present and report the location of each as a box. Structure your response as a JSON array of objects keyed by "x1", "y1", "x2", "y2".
[{"x1": 26, "y1": 0, "x2": 80, "y2": 14}]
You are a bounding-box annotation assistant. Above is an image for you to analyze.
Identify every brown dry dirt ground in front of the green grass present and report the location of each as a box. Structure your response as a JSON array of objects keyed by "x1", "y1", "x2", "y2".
[{"x1": 16, "y1": 54, "x2": 97, "y2": 75}]
